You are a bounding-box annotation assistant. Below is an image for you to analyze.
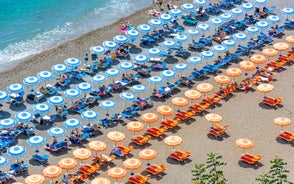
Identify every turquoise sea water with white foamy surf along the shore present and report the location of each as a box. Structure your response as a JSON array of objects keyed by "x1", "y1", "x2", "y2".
[{"x1": 0, "y1": 0, "x2": 150, "y2": 64}]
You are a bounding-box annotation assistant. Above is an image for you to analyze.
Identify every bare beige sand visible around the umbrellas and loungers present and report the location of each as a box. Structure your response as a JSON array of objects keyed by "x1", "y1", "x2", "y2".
[{"x1": 0, "y1": 0, "x2": 294, "y2": 184}]
